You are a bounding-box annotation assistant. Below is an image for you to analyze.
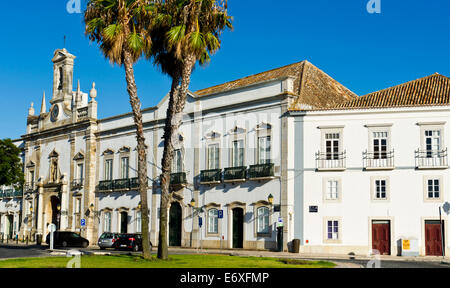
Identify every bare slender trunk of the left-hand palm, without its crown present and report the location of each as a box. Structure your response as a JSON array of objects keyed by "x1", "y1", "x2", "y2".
[{"x1": 123, "y1": 50, "x2": 151, "y2": 260}]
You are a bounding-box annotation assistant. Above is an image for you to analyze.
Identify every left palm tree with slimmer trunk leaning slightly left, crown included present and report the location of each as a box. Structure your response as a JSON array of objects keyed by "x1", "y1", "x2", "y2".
[{"x1": 84, "y1": 0, "x2": 154, "y2": 259}]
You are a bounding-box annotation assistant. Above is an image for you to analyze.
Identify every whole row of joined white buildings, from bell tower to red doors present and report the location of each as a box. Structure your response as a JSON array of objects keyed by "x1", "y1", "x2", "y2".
[{"x1": 5, "y1": 49, "x2": 450, "y2": 255}]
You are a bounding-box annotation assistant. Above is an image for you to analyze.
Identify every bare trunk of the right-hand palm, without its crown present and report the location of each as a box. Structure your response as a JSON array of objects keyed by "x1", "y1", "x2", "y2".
[{"x1": 158, "y1": 73, "x2": 180, "y2": 260}]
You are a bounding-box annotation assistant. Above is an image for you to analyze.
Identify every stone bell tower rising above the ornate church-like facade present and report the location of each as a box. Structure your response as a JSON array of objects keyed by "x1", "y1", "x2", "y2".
[{"x1": 50, "y1": 48, "x2": 76, "y2": 109}]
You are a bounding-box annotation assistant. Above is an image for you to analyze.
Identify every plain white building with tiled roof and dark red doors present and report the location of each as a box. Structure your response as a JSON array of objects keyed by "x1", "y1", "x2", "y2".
[{"x1": 291, "y1": 74, "x2": 450, "y2": 255}]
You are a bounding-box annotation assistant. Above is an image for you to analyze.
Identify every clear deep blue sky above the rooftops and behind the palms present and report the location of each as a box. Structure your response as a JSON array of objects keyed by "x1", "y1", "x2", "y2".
[{"x1": 0, "y1": 0, "x2": 450, "y2": 138}]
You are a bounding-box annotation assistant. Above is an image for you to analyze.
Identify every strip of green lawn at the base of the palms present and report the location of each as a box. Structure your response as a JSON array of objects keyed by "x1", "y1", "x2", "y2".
[{"x1": 0, "y1": 254, "x2": 335, "y2": 268}]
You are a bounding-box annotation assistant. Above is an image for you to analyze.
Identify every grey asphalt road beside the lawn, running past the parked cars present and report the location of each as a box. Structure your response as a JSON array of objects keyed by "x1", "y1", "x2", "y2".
[{"x1": 0, "y1": 244, "x2": 450, "y2": 268}]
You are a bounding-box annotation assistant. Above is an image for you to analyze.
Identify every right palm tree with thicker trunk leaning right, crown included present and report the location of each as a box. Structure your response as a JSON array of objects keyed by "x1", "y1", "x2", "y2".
[{"x1": 153, "y1": 0, "x2": 232, "y2": 259}]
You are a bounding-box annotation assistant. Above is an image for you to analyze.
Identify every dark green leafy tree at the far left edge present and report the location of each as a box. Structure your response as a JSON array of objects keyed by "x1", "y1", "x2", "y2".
[{"x1": 0, "y1": 139, "x2": 25, "y2": 188}]
